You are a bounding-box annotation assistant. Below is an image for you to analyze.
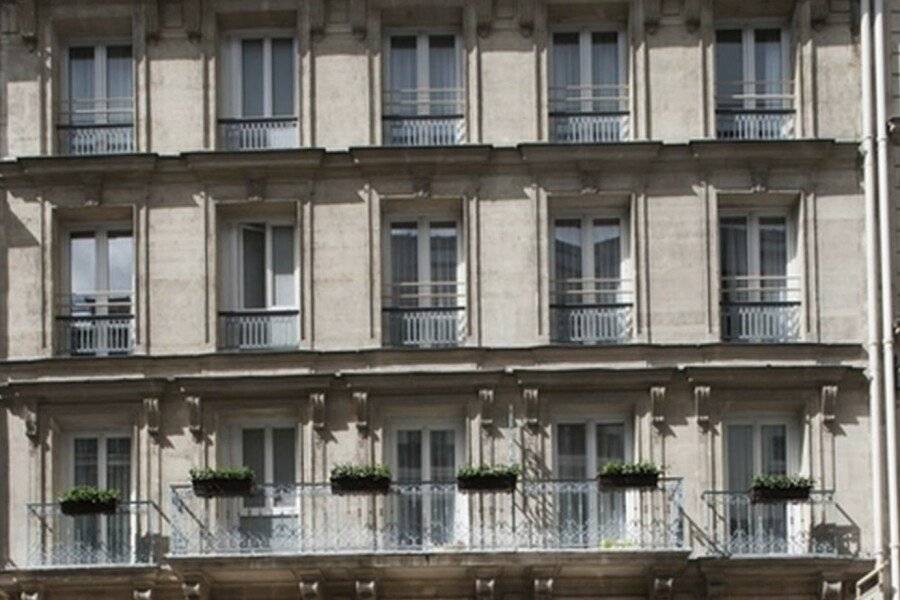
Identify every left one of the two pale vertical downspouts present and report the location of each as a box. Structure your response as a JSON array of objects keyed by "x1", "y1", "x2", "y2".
[{"x1": 859, "y1": 0, "x2": 884, "y2": 569}]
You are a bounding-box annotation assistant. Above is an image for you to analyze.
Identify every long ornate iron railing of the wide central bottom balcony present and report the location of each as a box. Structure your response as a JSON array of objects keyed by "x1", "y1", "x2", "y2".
[{"x1": 169, "y1": 480, "x2": 685, "y2": 557}]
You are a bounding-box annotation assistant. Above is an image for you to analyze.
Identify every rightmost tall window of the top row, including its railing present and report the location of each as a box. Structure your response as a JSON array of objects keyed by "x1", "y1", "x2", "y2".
[{"x1": 715, "y1": 27, "x2": 794, "y2": 139}]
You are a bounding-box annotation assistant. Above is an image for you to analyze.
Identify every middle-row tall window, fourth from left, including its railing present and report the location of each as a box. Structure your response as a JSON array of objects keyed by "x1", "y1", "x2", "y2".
[{"x1": 550, "y1": 216, "x2": 633, "y2": 344}]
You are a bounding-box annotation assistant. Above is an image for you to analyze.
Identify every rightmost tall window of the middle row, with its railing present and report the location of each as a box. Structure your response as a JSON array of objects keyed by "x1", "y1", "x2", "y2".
[{"x1": 719, "y1": 213, "x2": 800, "y2": 342}]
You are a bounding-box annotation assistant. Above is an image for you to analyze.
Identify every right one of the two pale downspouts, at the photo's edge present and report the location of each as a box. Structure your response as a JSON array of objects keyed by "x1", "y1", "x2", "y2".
[{"x1": 874, "y1": 0, "x2": 900, "y2": 600}]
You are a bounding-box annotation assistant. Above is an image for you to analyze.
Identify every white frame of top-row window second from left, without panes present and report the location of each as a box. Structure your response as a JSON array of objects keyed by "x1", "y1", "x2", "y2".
[{"x1": 220, "y1": 29, "x2": 300, "y2": 120}]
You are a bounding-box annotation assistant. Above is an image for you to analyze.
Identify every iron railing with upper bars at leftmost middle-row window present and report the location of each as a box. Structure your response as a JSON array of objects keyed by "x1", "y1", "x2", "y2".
[{"x1": 56, "y1": 290, "x2": 134, "y2": 356}]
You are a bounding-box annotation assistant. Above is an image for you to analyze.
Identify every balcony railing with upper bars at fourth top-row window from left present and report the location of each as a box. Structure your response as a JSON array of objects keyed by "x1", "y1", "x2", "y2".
[{"x1": 549, "y1": 84, "x2": 631, "y2": 144}]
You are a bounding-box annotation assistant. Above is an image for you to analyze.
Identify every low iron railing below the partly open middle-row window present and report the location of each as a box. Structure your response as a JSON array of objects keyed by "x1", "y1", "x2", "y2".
[{"x1": 219, "y1": 310, "x2": 300, "y2": 350}]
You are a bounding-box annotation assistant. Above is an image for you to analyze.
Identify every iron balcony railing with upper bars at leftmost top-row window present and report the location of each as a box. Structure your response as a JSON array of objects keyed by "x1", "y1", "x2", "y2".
[{"x1": 56, "y1": 98, "x2": 135, "y2": 156}]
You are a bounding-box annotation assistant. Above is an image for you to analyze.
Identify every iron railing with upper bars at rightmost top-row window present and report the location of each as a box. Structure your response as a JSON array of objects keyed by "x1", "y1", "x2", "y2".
[{"x1": 716, "y1": 80, "x2": 796, "y2": 140}]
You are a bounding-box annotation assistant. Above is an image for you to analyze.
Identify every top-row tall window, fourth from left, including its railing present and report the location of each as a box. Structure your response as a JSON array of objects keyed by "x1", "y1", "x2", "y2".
[{"x1": 550, "y1": 31, "x2": 630, "y2": 143}]
